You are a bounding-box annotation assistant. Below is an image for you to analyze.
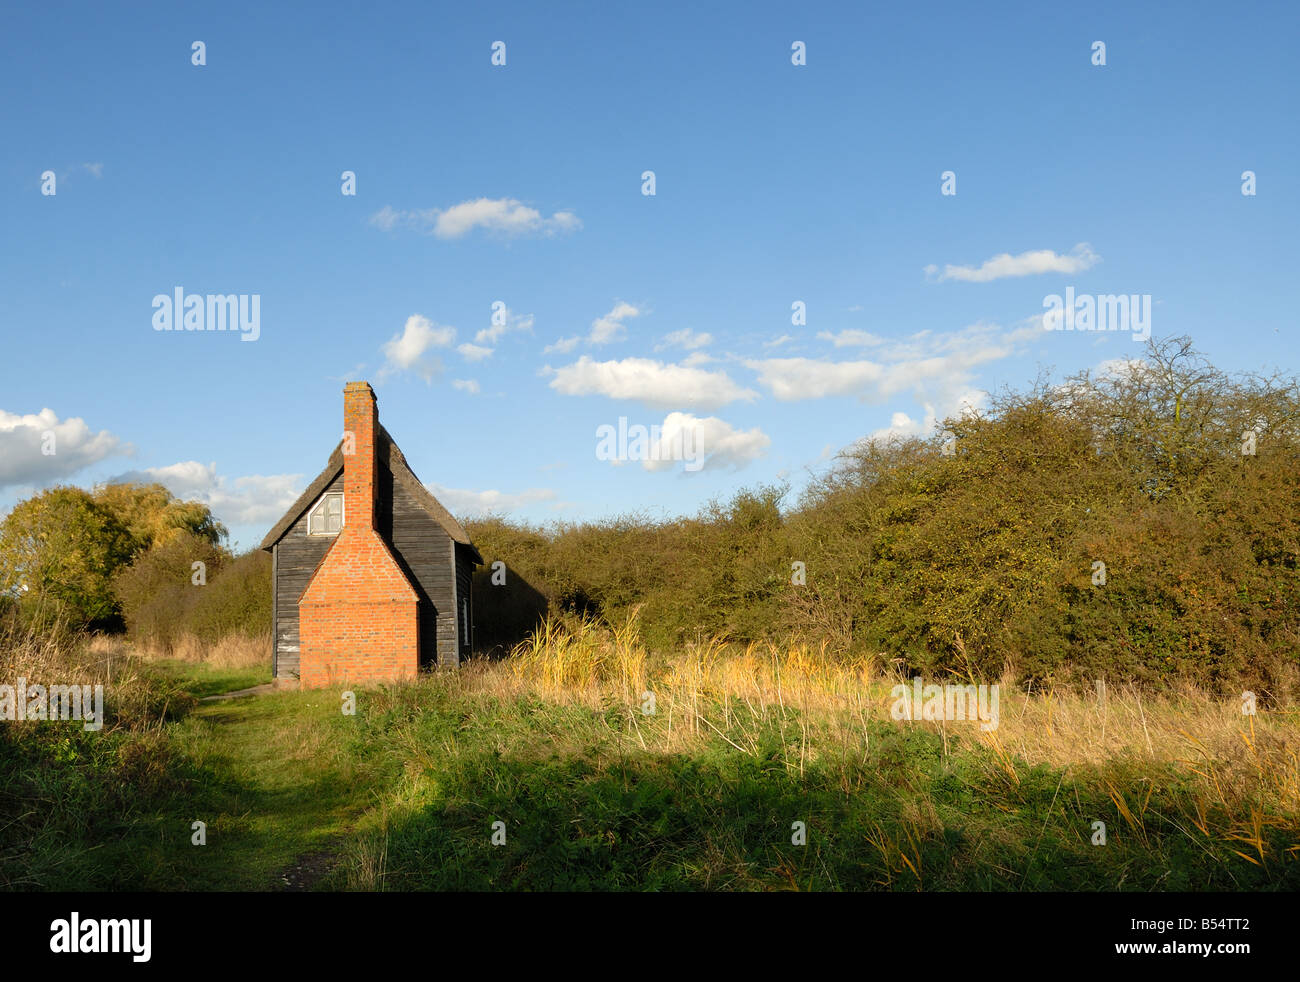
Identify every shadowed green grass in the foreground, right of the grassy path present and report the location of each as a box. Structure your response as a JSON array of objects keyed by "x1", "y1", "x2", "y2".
[{"x1": 338, "y1": 724, "x2": 1300, "y2": 891}]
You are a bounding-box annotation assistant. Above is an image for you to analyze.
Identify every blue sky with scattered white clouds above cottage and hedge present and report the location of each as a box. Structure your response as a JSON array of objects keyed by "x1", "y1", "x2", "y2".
[{"x1": 0, "y1": 3, "x2": 1300, "y2": 546}]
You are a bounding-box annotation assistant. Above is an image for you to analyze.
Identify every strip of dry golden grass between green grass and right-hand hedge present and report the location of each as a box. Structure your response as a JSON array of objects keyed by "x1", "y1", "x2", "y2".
[{"x1": 470, "y1": 615, "x2": 1300, "y2": 845}]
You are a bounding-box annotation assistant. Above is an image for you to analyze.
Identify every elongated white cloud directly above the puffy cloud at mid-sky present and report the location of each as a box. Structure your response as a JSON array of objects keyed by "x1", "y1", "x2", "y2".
[{"x1": 547, "y1": 355, "x2": 758, "y2": 410}]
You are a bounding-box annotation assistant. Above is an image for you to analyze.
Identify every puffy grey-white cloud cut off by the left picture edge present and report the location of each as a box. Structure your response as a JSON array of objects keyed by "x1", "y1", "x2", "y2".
[{"x1": 0, "y1": 408, "x2": 131, "y2": 488}]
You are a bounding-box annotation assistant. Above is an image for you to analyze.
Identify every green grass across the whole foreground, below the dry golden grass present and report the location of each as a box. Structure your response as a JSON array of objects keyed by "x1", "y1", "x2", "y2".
[{"x1": 0, "y1": 663, "x2": 1300, "y2": 891}]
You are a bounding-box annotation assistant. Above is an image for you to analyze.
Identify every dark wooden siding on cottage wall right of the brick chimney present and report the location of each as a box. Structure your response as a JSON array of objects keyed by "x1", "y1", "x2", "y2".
[{"x1": 376, "y1": 467, "x2": 458, "y2": 669}]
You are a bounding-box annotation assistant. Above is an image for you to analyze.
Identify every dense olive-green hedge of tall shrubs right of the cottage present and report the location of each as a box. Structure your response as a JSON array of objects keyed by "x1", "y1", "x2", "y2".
[{"x1": 471, "y1": 338, "x2": 1300, "y2": 695}]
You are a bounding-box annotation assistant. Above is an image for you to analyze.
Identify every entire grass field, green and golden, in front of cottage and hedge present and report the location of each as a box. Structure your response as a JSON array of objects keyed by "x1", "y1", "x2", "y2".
[{"x1": 0, "y1": 624, "x2": 1300, "y2": 891}]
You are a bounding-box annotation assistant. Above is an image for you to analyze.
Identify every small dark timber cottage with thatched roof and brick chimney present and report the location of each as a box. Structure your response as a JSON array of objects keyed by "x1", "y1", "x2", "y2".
[{"x1": 261, "y1": 382, "x2": 482, "y2": 688}]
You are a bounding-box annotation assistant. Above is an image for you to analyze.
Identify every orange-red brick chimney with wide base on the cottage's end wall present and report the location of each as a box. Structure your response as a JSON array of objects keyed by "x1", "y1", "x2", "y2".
[{"x1": 298, "y1": 382, "x2": 420, "y2": 688}]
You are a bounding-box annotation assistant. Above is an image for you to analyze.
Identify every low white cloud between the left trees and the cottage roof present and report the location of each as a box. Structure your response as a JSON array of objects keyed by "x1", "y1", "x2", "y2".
[{"x1": 111, "y1": 460, "x2": 303, "y2": 527}]
